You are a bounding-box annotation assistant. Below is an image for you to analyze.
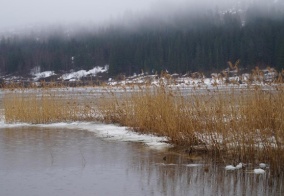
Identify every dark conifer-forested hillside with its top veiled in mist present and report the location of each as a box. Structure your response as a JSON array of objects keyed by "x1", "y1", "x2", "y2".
[{"x1": 0, "y1": 0, "x2": 284, "y2": 76}]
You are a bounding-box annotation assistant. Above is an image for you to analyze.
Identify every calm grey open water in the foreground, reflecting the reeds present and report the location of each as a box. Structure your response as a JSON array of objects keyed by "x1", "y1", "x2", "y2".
[{"x1": 0, "y1": 127, "x2": 283, "y2": 196}]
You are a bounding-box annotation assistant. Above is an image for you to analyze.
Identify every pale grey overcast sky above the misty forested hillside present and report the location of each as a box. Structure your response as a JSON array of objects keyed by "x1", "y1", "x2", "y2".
[{"x1": 0, "y1": 0, "x2": 276, "y2": 30}]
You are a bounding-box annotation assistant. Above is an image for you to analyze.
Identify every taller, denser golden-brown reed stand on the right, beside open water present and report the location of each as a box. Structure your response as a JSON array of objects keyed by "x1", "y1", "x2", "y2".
[{"x1": 100, "y1": 85, "x2": 284, "y2": 172}]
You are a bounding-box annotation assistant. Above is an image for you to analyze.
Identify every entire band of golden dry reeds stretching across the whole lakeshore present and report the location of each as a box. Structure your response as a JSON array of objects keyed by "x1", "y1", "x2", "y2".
[{"x1": 3, "y1": 85, "x2": 284, "y2": 171}]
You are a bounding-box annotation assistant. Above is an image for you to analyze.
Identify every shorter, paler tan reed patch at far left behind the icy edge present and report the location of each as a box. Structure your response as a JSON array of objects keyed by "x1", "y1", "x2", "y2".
[{"x1": 3, "y1": 89, "x2": 94, "y2": 124}]
